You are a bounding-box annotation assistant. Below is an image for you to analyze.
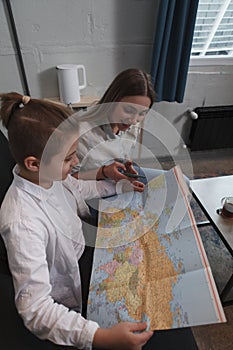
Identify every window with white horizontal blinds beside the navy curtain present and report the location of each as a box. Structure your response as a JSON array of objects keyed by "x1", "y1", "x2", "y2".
[{"x1": 191, "y1": 0, "x2": 233, "y2": 64}]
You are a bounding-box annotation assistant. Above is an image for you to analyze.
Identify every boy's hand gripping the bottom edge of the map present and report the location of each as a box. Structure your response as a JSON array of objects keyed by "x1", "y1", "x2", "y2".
[{"x1": 93, "y1": 322, "x2": 153, "y2": 350}]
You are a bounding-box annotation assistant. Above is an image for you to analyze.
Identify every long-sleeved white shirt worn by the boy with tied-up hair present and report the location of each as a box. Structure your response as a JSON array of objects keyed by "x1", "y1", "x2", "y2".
[{"x1": 0, "y1": 167, "x2": 115, "y2": 349}]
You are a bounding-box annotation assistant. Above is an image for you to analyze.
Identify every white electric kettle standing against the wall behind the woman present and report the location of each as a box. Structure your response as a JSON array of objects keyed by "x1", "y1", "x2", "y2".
[{"x1": 56, "y1": 64, "x2": 87, "y2": 104}]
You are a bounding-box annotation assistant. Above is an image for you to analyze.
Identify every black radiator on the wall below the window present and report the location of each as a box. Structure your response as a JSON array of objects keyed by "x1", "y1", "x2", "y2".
[{"x1": 189, "y1": 106, "x2": 233, "y2": 151}]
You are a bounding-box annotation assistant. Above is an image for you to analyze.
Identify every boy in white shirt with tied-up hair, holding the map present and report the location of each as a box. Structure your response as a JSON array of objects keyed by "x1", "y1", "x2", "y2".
[{"x1": 0, "y1": 93, "x2": 153, "y2": 350}]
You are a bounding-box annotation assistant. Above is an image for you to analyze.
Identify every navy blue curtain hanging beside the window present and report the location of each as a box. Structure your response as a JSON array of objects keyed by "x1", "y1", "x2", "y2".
[{"x1": 151, "y1": 0, "x2": 198, "y2": 102}]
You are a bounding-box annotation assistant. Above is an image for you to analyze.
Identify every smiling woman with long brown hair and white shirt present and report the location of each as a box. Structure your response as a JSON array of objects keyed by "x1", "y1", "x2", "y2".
[{"x1": 73, "y1": 68, "x2": 163, "y2": 182}]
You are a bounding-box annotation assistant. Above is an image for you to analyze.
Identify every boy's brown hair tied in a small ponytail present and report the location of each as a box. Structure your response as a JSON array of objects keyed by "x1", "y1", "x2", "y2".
[{"x1": 0, "y1": 92, "x2": 73, "y2": 167}]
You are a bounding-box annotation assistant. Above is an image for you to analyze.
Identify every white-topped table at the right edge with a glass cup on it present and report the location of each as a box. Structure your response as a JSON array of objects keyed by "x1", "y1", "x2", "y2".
[{"x1": 190, "y1": 175, "x2": 233, "y2": 305}]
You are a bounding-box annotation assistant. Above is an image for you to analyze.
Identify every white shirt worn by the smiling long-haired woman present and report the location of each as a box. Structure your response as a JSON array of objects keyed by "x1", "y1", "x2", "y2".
[{"x1": 74, "y1": 120, "x2": 140, "y2": 172}]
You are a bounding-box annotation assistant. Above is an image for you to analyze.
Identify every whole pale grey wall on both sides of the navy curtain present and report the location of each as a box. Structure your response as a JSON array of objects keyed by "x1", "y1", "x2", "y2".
[{"x1": 0, "y1": 0, "x2": 233, "y2": 155}]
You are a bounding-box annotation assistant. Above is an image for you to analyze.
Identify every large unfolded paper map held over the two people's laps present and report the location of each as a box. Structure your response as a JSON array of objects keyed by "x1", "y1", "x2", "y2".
[{"x1": 87, "y1": 167, "x2": 226, "y2": 330}]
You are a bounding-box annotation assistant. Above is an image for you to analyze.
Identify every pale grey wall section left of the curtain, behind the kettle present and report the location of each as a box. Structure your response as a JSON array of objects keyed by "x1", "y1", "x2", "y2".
[{"x1": 0, "y1": 0, "x2": 156, "y2": 97}]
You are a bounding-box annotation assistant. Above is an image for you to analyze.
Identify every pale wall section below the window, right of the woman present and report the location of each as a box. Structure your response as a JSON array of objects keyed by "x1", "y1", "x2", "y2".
[{"x1": 147, "y1": 65, "x2": 233, "y2": 159}]
